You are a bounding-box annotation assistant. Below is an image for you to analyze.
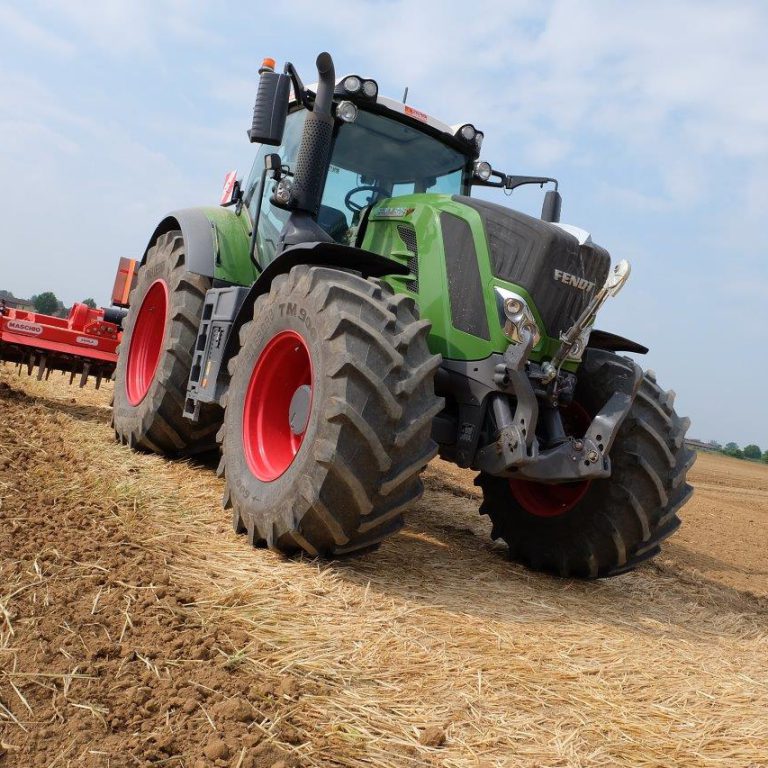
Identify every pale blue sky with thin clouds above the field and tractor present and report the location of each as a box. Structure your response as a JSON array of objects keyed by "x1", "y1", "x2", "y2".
[{"x1": 0, "y1": 0, "x2": 768, "y2": 448}]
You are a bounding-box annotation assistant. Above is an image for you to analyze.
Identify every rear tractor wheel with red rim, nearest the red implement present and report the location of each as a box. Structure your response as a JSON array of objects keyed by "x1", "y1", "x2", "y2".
[{"x1": 112, "y1": 230, "x2": 222, "y2": 456}]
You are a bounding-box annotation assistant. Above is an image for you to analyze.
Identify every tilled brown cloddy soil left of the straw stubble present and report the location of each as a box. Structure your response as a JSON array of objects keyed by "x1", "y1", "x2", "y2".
[{"x1": 0, "y1": 382, "x2": 311, "y2": 768}]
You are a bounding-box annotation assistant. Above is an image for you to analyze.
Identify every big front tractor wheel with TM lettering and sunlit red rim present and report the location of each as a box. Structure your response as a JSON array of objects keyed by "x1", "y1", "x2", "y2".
[{"x1": 220, "y1": 265, "x2": 442, "y2": 557}]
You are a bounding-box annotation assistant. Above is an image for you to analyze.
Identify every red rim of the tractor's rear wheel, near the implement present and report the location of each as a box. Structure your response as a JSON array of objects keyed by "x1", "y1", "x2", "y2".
[{"x1": 125, "y1": 280, "x2": 168, "y2": 405}]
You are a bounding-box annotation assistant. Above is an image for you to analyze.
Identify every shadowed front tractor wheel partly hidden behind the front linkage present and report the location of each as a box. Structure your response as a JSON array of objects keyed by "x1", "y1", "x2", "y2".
[{"x1": 475, "y1": 352, "x2": 696, "y2": 578}]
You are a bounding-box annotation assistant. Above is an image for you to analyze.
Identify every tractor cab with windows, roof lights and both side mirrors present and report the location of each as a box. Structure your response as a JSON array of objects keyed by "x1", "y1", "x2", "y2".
[{"x1": 243, "y1": 60, "x2": 560, "y2": 269}]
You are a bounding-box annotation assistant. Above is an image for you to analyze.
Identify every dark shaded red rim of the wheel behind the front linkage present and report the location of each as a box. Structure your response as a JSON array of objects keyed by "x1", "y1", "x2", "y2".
[{"x1": 509, "y1": 402, "x2": 592, "y2": 517}]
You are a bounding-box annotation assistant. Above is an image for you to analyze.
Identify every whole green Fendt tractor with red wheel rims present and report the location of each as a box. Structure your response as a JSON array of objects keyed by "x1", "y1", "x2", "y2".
[{"x1": 113, "y1": 53, "x2": 694, "y2": 578}]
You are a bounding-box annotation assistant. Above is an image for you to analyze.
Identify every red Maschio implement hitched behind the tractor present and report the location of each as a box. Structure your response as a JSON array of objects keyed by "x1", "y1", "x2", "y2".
[{"x1": 0, "y1": 304, "x2": 122, "y2": 387}]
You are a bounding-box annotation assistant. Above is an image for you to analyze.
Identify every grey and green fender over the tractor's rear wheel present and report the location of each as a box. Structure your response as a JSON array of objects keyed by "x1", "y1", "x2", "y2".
[{"x1": 141, "y1": 207, "x2": 258, "y2": 285}]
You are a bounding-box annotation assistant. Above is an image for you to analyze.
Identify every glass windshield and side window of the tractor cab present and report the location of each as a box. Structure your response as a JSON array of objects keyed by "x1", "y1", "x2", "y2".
[{"x1": 246, "y1": 109, "x2": 469, "y2": 265}]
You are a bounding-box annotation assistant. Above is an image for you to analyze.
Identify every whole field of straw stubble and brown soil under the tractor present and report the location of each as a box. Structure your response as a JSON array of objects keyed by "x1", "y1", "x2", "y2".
[{"x1": 0, "y1": 365, "x2": 768, "y2": 768}]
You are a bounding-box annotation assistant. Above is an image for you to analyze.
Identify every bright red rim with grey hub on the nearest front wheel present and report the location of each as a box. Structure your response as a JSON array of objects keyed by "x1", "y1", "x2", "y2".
[{"x1": 243, "y1": 331, "x2": 314, "y2": 483}]
